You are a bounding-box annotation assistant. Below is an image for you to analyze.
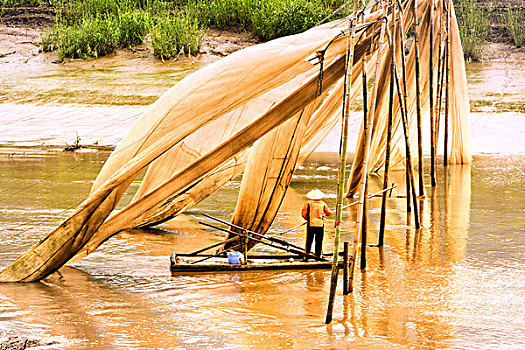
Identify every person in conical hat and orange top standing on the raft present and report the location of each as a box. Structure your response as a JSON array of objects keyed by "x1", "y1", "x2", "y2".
[{"x1": 301, "y1": 188, "x2": 332, "y2": 261}]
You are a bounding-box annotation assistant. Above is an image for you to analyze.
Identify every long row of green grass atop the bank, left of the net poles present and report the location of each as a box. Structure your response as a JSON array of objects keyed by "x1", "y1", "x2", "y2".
[{"x1": 34, "y1": 0, "x2": 345, "y2": 60}]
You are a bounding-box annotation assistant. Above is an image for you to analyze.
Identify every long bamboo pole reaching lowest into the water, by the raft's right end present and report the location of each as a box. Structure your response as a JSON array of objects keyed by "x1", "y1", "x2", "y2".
[{"x1": 325, "y1": 13, "x2": 355, "y2": 324}]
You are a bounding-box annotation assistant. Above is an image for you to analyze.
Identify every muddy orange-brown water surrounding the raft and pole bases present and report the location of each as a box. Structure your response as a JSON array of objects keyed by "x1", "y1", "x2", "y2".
[{"x1": 0, "y1": 149, "x2": 525, "y2": 349}]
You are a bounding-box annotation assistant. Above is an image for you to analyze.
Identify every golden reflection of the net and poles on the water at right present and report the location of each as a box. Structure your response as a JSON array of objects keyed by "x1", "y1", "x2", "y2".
[{"x1": 320, "y1": 165, "x2": 471, "y2": 349}]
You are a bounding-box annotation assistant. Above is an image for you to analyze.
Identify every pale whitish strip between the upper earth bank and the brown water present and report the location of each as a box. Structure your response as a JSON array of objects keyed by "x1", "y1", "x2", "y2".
[{"x1": 0, "y1": 53, "x2": 525, "y2": 154}]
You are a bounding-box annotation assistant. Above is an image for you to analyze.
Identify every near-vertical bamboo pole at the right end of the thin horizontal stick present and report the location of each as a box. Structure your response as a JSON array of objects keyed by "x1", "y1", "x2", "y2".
[{"x1": 377, "y1": 2, "x2": 396, "y2": 247}]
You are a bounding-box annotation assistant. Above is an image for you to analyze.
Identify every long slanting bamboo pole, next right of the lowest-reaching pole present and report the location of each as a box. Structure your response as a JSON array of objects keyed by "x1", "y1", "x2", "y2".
[{"x1": 349, "y1": 13, "x2": 386, "y2": 292}]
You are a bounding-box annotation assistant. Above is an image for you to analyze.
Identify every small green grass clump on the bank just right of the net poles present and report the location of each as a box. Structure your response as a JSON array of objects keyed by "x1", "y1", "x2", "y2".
[{"x1": 454, "y1": 0, "x2": 489, "y2": 61}]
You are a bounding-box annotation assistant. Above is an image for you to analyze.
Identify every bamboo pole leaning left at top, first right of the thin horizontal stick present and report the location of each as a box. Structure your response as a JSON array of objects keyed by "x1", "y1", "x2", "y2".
[{"x1": 394, "y1": 0, "x2": 419, "y2": 228}]
